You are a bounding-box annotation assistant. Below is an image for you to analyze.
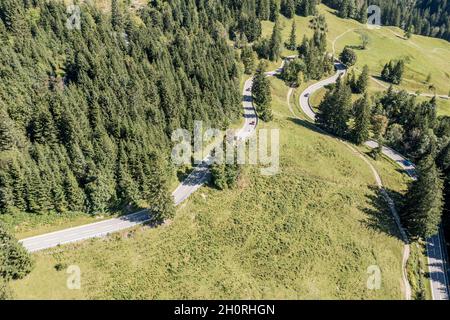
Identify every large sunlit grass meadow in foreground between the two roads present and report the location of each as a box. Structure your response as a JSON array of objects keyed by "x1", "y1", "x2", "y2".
[{"x1": 12, "y1": 79, "x2": 403, "y2": 299}]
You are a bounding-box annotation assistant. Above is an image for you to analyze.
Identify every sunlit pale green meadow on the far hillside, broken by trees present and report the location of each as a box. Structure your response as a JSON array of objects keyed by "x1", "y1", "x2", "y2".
[{"x1": 263, "y1": 4, "x2": 450, "y2": 115}]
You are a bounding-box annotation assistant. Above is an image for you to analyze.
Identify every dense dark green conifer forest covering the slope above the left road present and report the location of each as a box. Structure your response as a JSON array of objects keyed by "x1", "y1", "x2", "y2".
[{"x1": 0, "y1": 0, "x2": 246, "y2": 216}]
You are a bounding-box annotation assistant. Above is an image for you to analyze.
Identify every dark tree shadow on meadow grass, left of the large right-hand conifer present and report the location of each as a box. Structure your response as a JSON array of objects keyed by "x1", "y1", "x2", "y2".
[{"x1": 360, "y1": 186, "x2": 403, "y2": 241}]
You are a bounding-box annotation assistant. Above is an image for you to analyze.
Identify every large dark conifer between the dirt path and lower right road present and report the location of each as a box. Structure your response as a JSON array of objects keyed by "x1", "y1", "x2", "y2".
[{"x1": 401, "y1": 154, "x2": 443, "y2": 239}]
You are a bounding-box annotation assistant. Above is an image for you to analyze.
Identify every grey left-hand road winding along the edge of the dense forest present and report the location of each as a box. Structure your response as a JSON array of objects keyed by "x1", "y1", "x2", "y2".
[{"x1": 19, "y1": 60, "x2": 284, "y2": 252}]
